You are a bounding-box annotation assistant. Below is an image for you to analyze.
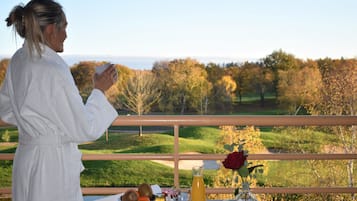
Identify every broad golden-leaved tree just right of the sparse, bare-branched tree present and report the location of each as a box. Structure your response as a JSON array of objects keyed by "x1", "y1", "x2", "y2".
[{"x1": 153, "y1": 58, "x2": 209, "y2": 114}]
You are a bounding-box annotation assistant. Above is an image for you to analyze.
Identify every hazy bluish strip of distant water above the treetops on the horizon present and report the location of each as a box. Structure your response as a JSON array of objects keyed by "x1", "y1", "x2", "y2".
[{"x1": 0, "y1": 54, "x2": 254, "y2": 70}]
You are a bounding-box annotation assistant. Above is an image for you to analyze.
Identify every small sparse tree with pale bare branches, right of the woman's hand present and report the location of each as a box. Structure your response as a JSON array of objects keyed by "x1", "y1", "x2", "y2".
[{"x1": 122, "y1": 70, "x2": 160, "y2": 136}]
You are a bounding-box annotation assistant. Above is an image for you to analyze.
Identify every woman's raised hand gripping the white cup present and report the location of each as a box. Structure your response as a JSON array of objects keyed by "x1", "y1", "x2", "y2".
[{"x1": 93, "y1": 64, "x2": 118, "y2": 93}]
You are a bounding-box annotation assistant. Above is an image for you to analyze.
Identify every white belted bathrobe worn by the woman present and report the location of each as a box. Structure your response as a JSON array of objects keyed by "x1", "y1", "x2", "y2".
[{"x1": 0, "y1": 42, "x2": 118, "y2": 201}]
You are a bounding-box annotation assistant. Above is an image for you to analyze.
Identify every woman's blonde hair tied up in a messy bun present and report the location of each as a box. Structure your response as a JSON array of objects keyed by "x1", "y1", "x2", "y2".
[{"x1": 6, "y1": 0, "x2": 66, "y2": 55}]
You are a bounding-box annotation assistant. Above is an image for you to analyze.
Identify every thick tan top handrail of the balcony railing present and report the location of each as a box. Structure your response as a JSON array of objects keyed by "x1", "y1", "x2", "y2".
[{"x1": 113, "y1": 115, "x2": 357, "y2": 126}]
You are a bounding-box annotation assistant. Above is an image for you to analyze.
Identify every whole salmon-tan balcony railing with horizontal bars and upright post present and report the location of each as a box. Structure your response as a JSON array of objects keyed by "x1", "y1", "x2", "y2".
[{"x1": 0, "y1": 115, "x2": 357, "y2": 195}]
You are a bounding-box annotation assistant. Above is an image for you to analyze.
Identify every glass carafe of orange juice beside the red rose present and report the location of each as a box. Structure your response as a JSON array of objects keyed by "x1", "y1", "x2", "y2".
[{"x1": 190, "y1": 166, "x2": 206, "y2": 201}]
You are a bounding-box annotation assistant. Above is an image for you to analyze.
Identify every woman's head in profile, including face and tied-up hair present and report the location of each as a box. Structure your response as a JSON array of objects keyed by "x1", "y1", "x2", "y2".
[{"x1": 6, "y1": 0, "x2": 67, "y2": 54}]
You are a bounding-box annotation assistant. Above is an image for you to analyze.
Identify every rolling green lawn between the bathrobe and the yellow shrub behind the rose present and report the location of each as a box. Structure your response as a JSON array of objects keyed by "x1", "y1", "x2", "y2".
[{"x1": 79, "y1": 127, "x2": 219, "y2": 187}]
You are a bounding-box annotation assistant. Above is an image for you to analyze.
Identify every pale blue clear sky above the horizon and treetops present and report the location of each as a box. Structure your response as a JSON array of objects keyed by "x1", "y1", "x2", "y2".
[{"x1": 0, "y1": 0, "x2": 357, "y2": 60}]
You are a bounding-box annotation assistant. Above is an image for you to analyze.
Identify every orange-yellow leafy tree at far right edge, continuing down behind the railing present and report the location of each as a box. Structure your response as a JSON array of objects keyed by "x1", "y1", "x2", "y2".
[{"x1": 310, "y1": 58, "x2": 357, "y2": 200}]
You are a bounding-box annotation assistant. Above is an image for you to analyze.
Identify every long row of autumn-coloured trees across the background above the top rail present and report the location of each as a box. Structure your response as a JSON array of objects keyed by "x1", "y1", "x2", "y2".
[{"x1": 0, "y1": 50, "x2": 357, "y2": 115}]
